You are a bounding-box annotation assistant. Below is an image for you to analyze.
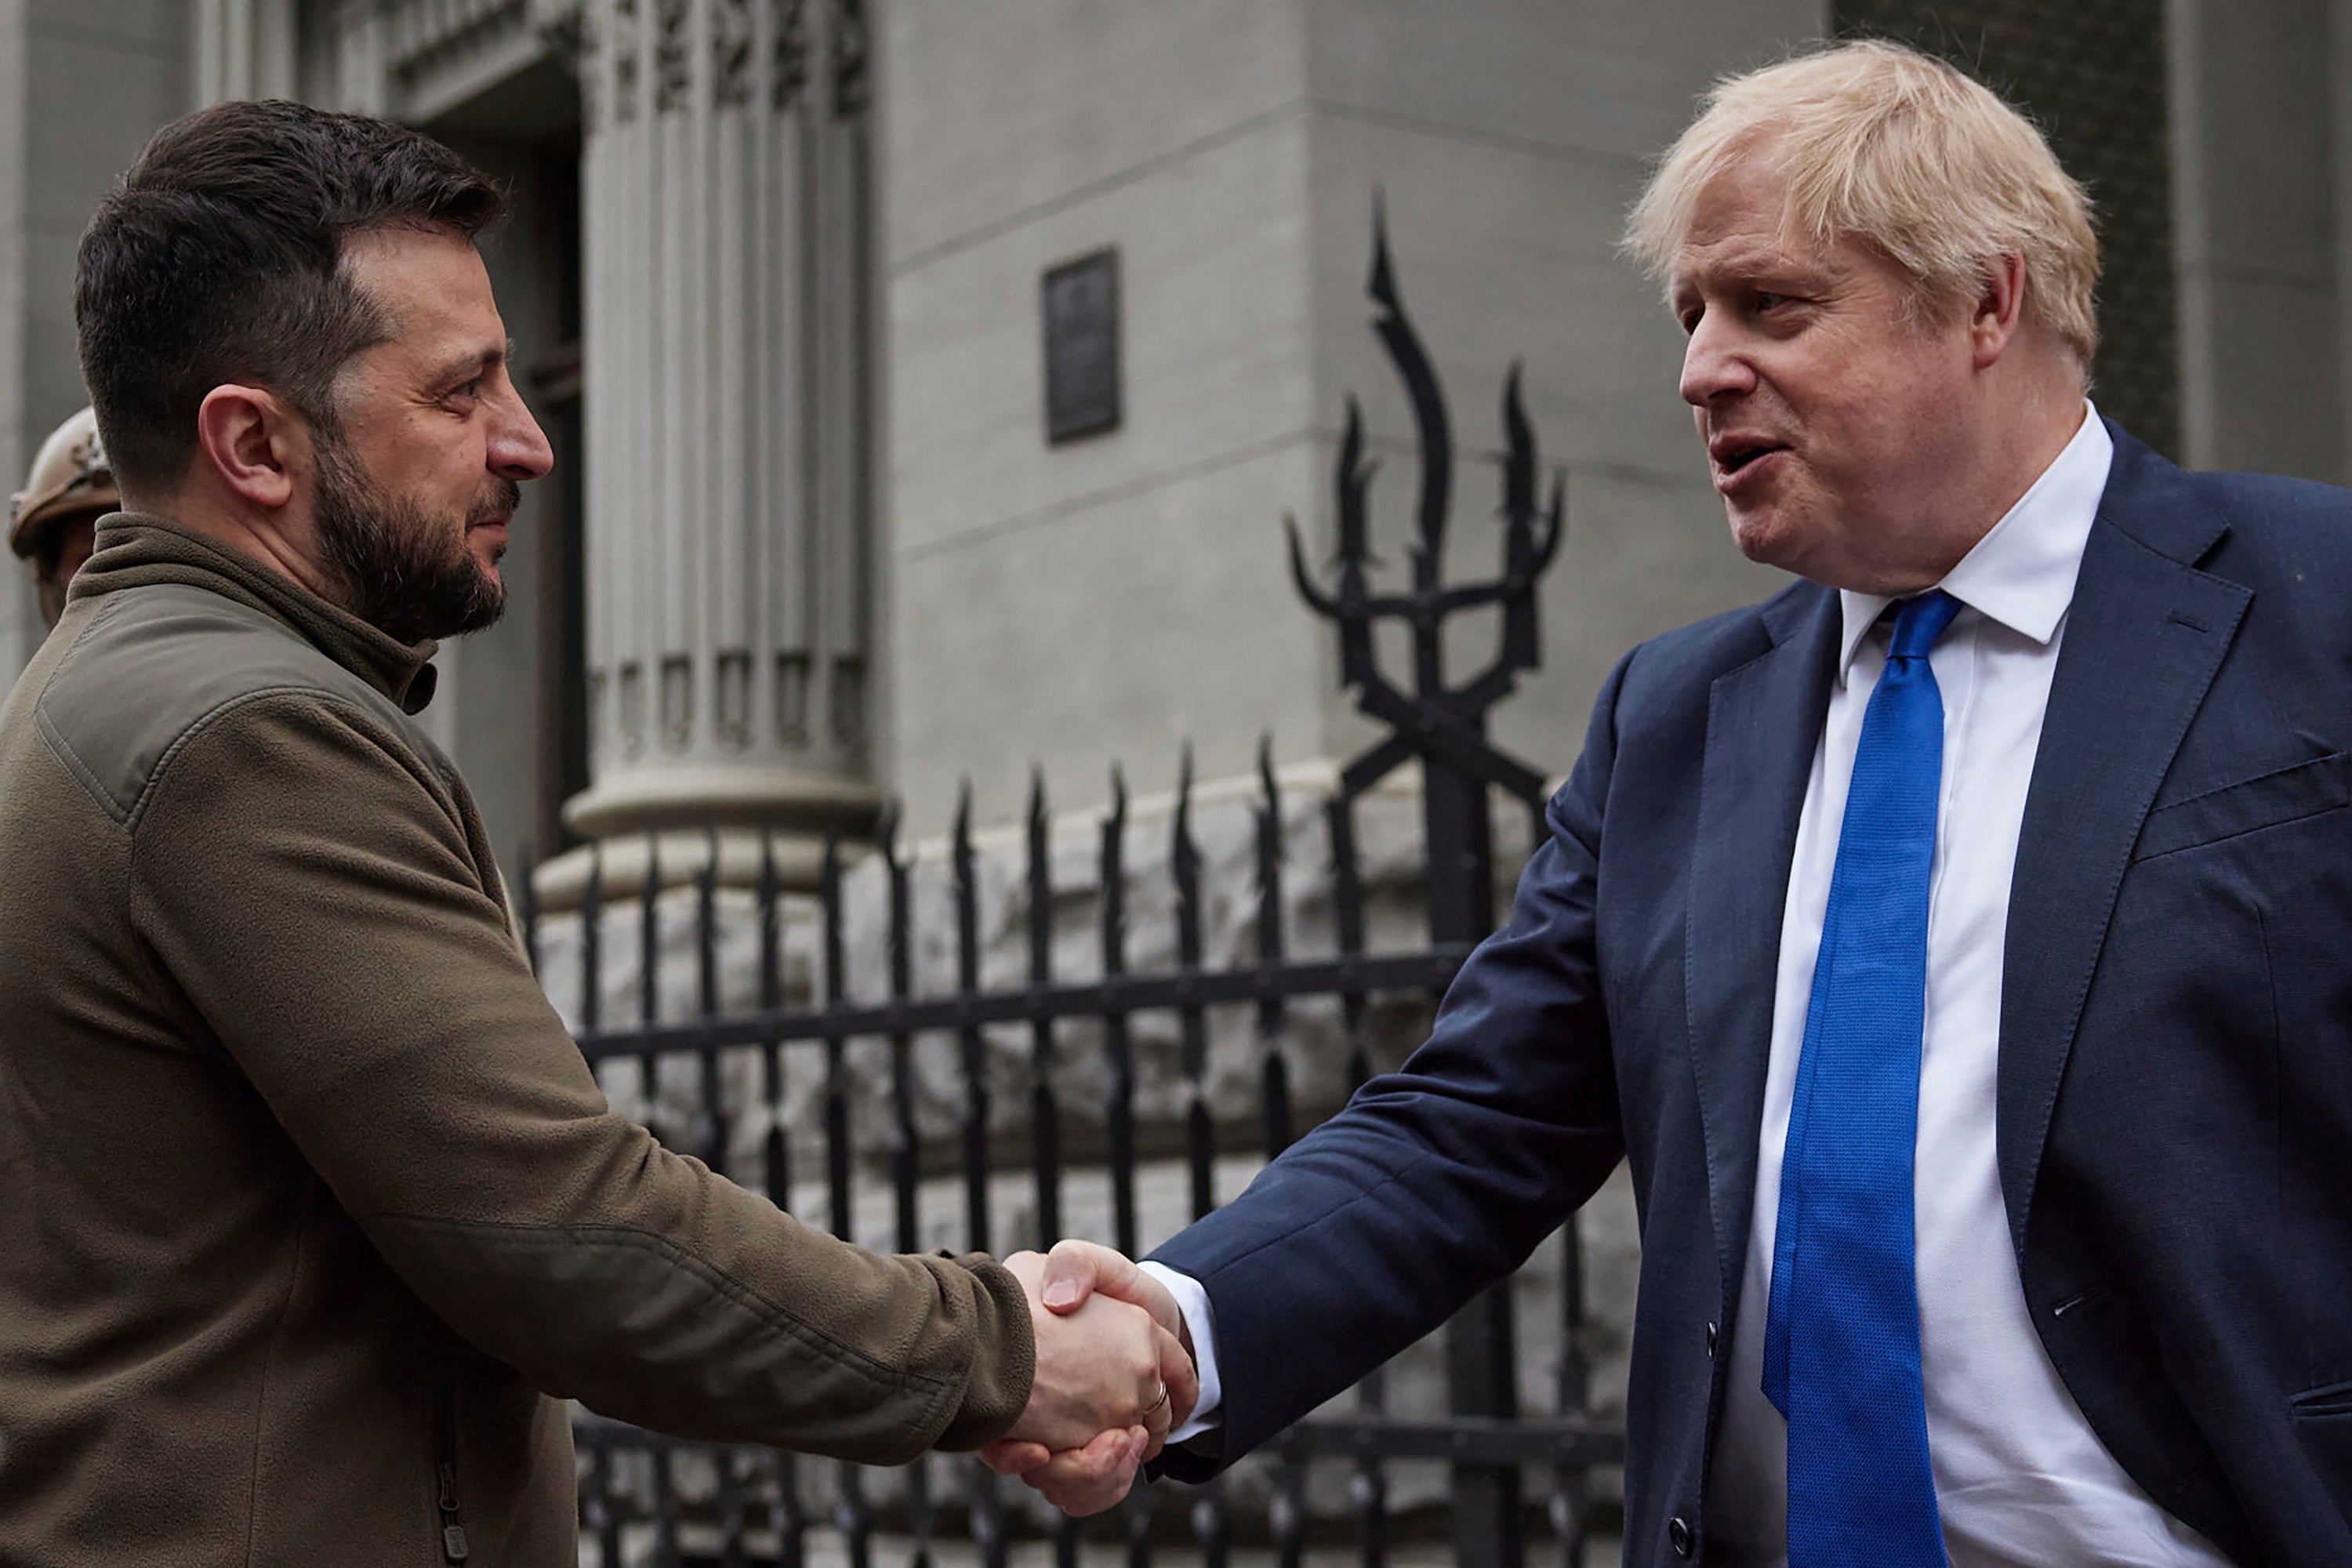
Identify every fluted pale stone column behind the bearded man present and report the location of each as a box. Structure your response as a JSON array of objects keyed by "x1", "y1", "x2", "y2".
[{"x1": 541, "y1": 0, "x2": 882, "y2": 900}]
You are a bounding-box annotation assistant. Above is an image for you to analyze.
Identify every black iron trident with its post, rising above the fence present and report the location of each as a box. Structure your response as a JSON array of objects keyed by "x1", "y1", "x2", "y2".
[{"x1": 1284, "y1": 205, "x2": 1583, "y2": 1568}]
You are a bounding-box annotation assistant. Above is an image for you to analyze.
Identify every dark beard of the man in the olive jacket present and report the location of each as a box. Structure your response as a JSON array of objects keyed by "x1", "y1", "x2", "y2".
[{"x1": 313, "y1": 433, "x2": 522, "y2": 642}]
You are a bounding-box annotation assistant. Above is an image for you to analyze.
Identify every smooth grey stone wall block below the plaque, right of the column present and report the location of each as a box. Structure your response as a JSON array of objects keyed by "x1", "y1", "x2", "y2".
[{"x1": 896, "y1": 445, "x2": 1331, "y2": 829}]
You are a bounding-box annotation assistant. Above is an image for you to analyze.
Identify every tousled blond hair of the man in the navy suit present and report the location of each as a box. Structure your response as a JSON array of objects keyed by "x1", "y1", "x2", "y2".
[{"x1": 1625, "y1": 40, "x2": 2098, "y2": 369}]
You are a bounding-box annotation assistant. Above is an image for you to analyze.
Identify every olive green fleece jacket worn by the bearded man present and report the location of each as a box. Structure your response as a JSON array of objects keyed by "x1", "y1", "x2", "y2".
[{"x1": 0, "y1": 515, "x2": 1033, "y2": 1568}]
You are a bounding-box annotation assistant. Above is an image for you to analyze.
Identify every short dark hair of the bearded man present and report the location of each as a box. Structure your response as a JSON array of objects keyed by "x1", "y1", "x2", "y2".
[{"x1": 73, "y1": 99, "x2": 506, "y2": 492}]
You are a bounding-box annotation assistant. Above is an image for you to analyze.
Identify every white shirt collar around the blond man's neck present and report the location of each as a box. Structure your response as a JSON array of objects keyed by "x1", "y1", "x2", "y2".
[{"x1": 1837, "y1": 402, "x2": 2114, "y2": 684}]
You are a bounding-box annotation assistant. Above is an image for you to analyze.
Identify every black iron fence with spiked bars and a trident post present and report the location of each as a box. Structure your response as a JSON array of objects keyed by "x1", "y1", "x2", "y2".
[{"x1": 522, "y1": 215, "x2": 1623, "y2": 1568}]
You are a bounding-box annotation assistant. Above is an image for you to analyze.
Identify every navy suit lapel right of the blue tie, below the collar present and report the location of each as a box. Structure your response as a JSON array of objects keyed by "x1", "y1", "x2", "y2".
[{"x1": 1997, "y1": 430, "x2": 2253, "y2": 1255}]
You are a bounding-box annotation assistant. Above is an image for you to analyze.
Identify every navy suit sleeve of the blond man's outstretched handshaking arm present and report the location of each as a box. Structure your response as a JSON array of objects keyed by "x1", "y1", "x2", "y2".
[{"x1": 1152, "y1": 656, "x2": 1630, "y2": 1481}]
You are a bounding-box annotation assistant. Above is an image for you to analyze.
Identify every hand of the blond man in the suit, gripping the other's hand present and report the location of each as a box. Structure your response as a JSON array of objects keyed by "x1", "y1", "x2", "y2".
[{"x1": 981, "y1": 1241, "x2": 1200, "y2": 1514}]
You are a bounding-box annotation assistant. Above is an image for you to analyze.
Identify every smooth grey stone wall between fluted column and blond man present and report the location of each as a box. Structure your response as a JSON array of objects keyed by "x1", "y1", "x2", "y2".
[{"x1": 884, "y1": 0, "x2": 1823, "y2": 846}]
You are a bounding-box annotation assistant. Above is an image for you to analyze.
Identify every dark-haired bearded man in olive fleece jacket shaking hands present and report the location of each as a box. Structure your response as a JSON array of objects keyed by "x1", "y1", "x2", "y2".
[{"x1": 0, "y1": 103, "x2": 1192, "y2": 1568}]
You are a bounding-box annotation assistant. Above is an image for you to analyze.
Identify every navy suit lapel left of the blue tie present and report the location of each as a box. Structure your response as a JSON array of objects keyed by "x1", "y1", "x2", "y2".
[{"x1": 1684, "y1": 586, "x2": 1842, "y2": 1302}]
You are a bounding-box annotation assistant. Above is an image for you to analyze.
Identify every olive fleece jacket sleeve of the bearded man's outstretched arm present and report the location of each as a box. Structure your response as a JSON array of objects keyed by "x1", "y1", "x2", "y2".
[{"x1": 132, "y1": 694, "x2": 1033, "y2": 1465}]
